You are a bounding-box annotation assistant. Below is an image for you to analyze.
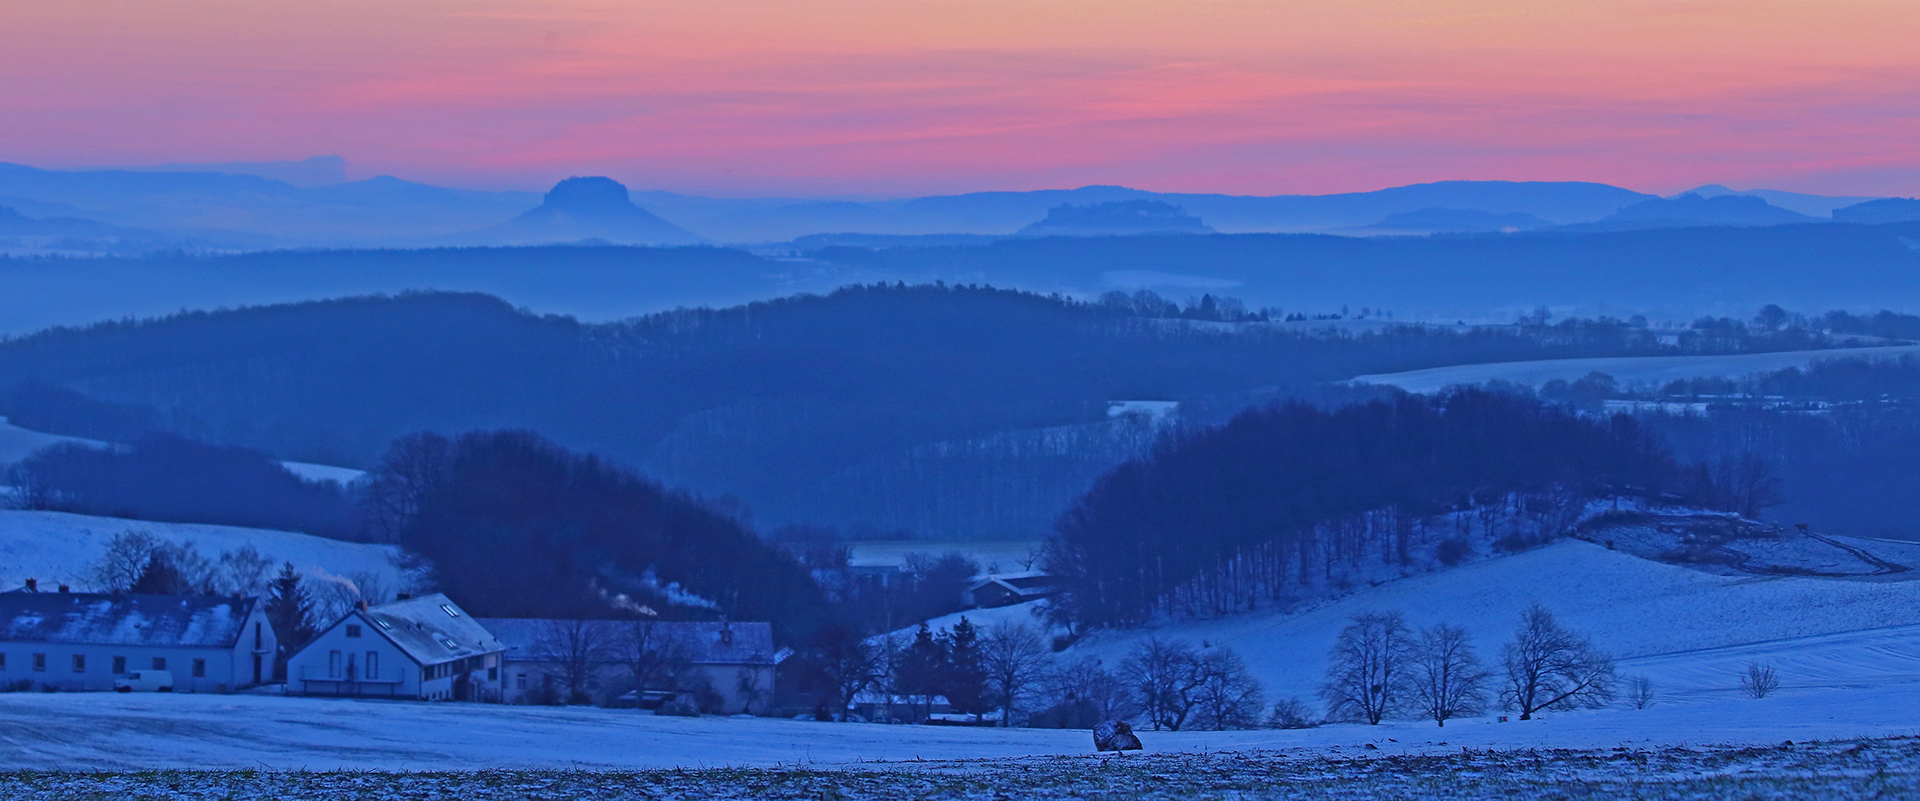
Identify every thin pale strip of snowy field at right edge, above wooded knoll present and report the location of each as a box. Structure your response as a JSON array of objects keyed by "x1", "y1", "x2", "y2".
[{"x1": 1354, "y1": 346, "x2": 1920, "y2": 392}]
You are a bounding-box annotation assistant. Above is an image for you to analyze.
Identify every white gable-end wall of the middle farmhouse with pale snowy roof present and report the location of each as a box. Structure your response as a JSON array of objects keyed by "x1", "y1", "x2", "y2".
[{"x1": 286, "y1": 613, "x2": 420, "y2": 697}]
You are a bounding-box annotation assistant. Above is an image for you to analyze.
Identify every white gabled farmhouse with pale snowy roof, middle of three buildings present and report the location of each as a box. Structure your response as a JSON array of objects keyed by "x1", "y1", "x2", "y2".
[{"x1": 286, "y1": 594, "x2": 505, "y2": 701}]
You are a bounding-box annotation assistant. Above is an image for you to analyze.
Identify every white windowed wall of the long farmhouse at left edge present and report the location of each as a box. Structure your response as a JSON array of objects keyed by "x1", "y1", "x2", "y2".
[{"x1": 0, "y1": 609, "x2": 276, "y2": 693}]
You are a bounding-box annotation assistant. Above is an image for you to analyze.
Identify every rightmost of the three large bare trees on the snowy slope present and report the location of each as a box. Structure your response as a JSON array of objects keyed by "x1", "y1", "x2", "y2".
[{"x1": 1500, "y1": 603, "x2": 1613, "y2": 720}]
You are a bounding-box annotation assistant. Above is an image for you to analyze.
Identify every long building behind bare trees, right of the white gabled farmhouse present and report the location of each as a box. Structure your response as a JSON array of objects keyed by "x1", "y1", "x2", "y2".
[{"x1": 482, "y1": 619, "x2": 791, "y2": 715}]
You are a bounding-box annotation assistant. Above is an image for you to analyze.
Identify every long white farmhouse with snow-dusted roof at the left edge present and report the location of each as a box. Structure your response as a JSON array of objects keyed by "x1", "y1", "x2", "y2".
[{"x1": 0, "y1": 582, "x2": 276, "y2": 693}]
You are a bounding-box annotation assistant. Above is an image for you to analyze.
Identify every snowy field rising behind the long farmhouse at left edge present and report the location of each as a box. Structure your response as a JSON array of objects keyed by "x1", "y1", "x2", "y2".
[{"x1": 0, "y1": 511, "x2": 407, "y2": 592}]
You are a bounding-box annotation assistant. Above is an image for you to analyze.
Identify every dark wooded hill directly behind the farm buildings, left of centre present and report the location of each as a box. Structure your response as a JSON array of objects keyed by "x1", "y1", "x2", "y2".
[{"x1": 367, "y1": 430, "x2": 826, "y2": 640}]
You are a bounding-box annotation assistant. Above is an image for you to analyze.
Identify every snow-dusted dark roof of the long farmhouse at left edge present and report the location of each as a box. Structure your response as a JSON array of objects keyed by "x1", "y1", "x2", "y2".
[{"x1": 0, "y1": 592, "x2": 259, "y2": 647}]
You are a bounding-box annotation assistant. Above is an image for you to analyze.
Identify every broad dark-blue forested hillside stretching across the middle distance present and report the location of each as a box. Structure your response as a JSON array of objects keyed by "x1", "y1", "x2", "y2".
[{"x1": 0, "y1": 284, "x2": 1745, "y2": 536}]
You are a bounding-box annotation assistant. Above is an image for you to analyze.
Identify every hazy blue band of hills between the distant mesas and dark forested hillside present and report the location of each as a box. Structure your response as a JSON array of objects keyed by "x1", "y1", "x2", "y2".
[{"x1": 0, "y1": 223, "x2": 1920, "y2": 334}]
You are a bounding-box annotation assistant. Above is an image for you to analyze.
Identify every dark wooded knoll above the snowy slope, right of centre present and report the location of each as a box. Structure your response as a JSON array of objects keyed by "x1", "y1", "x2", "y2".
[{"x1": 1046, "y1": 390, "x2": 1674, "y2": 626}]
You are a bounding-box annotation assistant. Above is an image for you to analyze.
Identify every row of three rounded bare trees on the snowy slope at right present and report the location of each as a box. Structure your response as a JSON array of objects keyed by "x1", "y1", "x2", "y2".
[{"x1": 1321, "y1": 603, "x2": 1620, "y2": 726}]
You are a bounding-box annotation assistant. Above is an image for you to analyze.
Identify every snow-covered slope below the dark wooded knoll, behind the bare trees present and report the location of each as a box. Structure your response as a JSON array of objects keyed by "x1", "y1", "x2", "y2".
[{"x1": 1064, "y1": 540, "x2": 1920, "y2": 699}]
